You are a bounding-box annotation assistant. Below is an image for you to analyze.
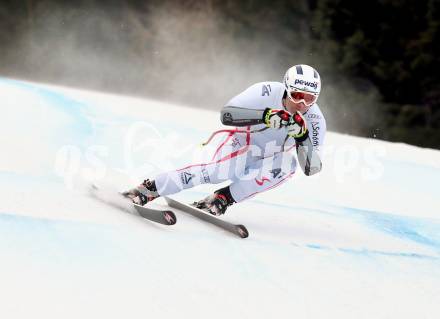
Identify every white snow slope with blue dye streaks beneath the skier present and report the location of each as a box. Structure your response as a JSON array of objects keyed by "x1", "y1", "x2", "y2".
[{"x1": 0, "y1": 78, "x2": 440, "y2": 318}]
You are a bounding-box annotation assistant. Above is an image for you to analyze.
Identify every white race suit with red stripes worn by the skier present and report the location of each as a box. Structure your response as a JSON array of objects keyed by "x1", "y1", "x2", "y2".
[{"x1": 155, "y1": 82, "x2": 326, "y2": 202}]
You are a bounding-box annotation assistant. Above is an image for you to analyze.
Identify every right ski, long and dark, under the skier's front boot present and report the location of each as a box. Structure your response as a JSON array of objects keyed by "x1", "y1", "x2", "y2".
[{"x1": 164, "y1": 196, "x2": 249, "y2": 238}]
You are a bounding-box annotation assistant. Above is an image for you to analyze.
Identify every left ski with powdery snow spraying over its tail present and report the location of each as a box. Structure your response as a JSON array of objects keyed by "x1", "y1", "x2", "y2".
[{"x1": 90, "y1": 185, "x2": 177, "y2": 226}]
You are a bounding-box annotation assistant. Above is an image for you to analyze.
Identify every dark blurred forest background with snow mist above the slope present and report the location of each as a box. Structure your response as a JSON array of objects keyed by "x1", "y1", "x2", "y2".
[{"x1": 0, "y1": 0, "x2": 440, "y2": 148}]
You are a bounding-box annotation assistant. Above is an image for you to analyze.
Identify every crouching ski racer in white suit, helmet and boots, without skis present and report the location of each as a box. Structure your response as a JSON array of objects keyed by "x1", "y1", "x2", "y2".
[{"x1": 124, "y1": 64, "x2": 326, "y2": 215}]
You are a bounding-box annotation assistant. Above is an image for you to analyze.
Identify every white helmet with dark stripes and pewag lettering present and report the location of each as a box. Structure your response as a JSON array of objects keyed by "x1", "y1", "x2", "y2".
[{"x1": 284, "y1": 64, "x2": 321, "y2": 105}]
